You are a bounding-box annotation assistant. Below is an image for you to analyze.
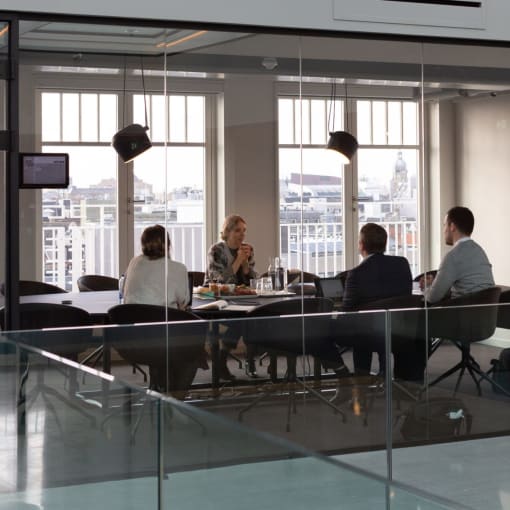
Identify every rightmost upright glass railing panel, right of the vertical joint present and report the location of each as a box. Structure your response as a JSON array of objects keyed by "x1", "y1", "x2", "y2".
[{"x1": 386, "y1": 300, "x2": 510, "y2": 509}]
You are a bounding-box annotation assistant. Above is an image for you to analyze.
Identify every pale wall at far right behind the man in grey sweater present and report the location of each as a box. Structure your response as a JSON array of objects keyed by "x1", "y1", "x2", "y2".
[{"x1": 457, "y1": 95, "x2": 510, "y2": 285}]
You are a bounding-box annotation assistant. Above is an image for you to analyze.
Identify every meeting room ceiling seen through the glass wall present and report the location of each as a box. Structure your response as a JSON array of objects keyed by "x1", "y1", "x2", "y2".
[{"x1": 9, "y1": 21, "x2": 510, "y2": 99}]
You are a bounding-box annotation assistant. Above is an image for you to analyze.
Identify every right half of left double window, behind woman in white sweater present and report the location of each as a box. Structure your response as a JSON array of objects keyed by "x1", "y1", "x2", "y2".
[{"x1": 133, "y1": 95, "x2": 206, "y2": 271}]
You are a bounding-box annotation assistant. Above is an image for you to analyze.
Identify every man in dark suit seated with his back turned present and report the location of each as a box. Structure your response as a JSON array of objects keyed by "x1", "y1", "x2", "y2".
[{"x1": 336, "y1": 223, "x2": 413, "y2": 378}]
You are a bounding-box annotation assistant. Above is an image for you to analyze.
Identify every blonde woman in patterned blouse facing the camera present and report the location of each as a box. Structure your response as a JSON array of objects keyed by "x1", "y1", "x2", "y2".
[{"x1": 205, "y1": 214, "x2": 257, "y2": 380}]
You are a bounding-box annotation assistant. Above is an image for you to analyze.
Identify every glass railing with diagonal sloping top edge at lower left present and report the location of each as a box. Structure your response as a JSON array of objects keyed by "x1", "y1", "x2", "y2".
[{"x1": 0, "y1": 326, "x2": 470, "y2": 510}]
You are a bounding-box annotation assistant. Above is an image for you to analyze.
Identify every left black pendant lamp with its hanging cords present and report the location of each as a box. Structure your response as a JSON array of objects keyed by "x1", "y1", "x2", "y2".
[{"x1": 112, "y1": 59, "x2": 152, "y2": 163}]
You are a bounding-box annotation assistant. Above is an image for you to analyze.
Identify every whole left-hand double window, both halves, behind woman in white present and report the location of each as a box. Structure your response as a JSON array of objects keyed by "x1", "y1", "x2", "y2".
[{"x1": 40, "y1": 91, "x2": 206, "y2": 290}]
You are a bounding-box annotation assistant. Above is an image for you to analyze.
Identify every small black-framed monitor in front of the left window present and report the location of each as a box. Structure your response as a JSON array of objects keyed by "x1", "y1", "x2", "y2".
[{"x1": 19, "y1": 152, "x2": 69, "y2": 188}]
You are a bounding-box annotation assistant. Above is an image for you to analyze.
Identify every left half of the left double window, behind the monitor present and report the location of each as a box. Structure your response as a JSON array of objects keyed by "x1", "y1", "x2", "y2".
[{"x1": 41, "y1": 92, "x2": 118, "y2": 290}]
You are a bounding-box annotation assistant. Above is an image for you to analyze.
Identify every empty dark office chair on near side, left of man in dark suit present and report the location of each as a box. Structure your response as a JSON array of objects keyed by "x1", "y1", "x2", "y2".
[{"x1": 238, "y1": 298, "x2": 346, "y2": 432}]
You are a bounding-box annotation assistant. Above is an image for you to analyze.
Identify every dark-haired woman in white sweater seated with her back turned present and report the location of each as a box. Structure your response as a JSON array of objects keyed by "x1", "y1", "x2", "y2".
[{"x1": 123, "y1": 225, "x2": 209, "y2": 398}]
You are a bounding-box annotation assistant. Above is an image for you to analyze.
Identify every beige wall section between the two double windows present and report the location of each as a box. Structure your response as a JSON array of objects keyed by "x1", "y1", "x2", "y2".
[{"x1": 224, "y1": 76, "x2": 279, "y2": 272}]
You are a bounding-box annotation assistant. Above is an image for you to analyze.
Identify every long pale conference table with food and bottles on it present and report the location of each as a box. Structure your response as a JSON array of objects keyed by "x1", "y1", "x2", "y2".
[{"x1": 0, "y1": 290, "x2": 297, "y2": 388}]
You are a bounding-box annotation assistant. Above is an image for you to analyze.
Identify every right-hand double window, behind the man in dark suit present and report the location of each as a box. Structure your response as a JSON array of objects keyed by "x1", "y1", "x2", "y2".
[{"x1": 278, "y1": 97, "x2": 420, "y2": 275}]
